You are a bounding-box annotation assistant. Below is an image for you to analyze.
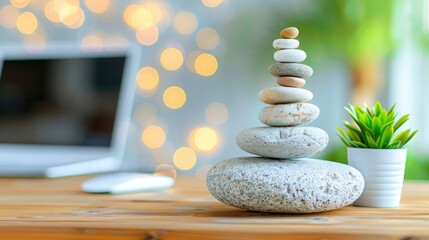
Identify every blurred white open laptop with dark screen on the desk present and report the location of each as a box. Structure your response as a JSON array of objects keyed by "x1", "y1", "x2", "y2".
[{"x1": 0, "y1": 45, "x2": 140, "y2": 177}]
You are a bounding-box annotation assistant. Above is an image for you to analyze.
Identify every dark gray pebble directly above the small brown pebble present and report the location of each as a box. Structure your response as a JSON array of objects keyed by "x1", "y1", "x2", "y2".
[{"x1": 268, "y1": 63, "x2": 313, "y2": 78}]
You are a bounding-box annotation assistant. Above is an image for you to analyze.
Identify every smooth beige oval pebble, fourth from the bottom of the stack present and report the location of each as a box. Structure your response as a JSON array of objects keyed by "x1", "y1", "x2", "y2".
[{"x1": 258, "y1": 87, "x2": 313, "y2": 104}]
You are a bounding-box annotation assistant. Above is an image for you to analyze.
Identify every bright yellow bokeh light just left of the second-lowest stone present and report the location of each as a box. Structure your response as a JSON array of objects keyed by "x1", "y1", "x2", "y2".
[{"x1": 188, "y1": 127, "x2": 218, "y2": 152}]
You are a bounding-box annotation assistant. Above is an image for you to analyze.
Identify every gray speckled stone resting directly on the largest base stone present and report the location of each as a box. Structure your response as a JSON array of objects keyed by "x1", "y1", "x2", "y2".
[{"x1": 236, "y1": 127, "x2": 329, "y2": 158}]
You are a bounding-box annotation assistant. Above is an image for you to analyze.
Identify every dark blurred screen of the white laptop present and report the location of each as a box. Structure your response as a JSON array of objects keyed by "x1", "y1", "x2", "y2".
[{"x1": 0, "y1": 56, "x2": 125, "y2": 146}]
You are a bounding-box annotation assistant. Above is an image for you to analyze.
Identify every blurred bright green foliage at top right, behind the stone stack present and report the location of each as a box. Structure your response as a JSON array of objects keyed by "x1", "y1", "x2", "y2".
[{"x1": 277, "y1": 0, "x2": 394, "y2": 64}]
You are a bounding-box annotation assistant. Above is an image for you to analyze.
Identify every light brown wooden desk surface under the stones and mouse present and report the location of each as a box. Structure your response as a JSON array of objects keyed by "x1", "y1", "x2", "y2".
[{"x1": 0, "y1": 176, "x2": 429, "y2": 240}]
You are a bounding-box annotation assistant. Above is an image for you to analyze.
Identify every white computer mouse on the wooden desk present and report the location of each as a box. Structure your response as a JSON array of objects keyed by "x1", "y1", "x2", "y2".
[{"x1": 81, "y1": 172, "x2": 174, "y2": 194}]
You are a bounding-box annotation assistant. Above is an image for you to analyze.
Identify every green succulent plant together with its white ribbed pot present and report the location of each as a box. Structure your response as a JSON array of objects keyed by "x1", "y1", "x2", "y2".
[{"x1": 337, "y1": 102, "x2": 417, "y2": 207}]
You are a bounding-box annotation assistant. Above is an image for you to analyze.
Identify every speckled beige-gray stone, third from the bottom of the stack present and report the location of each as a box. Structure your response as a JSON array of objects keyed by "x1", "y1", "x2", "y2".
[{"x1": 259, "y1": 103, "x2": 320, "y2": 127}]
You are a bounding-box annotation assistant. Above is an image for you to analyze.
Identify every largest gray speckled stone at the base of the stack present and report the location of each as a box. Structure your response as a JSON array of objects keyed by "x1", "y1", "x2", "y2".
[{"x1": 207, "y1": 157, "x2": 364, "y2": 213}]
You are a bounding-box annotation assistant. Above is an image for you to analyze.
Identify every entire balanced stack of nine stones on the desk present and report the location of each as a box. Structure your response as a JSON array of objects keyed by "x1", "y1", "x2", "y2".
[{"x1": 207, "y1": 27, "x2": 364, "y2": 213}]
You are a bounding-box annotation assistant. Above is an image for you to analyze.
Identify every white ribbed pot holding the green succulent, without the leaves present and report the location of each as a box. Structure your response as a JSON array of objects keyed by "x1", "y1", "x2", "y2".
[{"x1": 347, "y1": 148, "x2": 407, "y2": 208}]
